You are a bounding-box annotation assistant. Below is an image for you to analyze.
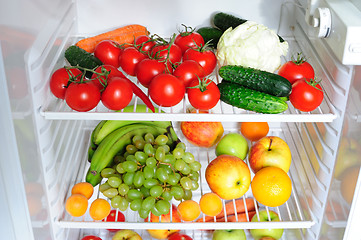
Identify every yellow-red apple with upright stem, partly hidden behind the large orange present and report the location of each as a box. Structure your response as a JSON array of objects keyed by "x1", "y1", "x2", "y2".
[{"x1": 248, "y1": 136, "x2": 292, "y2": 173}]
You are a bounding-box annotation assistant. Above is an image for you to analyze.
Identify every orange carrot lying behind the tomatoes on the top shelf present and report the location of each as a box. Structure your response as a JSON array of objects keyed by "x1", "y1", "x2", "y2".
[{"x1": 75, "y1": 24, "x2": 149, "y2": 53}]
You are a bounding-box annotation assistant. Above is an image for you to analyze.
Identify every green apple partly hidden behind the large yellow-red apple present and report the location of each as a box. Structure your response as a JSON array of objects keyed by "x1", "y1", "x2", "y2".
[{"x1": 216, "y1": 133, "x2": 248, "y2": 160}]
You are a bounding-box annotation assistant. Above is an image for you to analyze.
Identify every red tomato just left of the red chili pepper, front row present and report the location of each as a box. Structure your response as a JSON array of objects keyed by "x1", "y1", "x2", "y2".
[{"x1": 101, "y1": 77, "x2": 133, "y2": 110}]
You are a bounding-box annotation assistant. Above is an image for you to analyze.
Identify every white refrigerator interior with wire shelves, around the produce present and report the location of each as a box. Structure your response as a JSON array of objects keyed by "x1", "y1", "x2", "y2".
[{"x1": 0, "y1": 0, "x2": 361, "y2": 240}]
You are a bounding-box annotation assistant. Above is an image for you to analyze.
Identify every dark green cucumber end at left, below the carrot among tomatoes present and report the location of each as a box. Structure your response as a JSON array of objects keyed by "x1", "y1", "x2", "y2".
[{"x1": 65, "y1": 45, "x2": 103, "y2": 78}]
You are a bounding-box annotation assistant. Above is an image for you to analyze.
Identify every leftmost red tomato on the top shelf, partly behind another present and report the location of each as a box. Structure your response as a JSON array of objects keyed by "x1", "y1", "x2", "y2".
[{"x1": 49, "y1": 68, "x2": 82, "y2": 99}]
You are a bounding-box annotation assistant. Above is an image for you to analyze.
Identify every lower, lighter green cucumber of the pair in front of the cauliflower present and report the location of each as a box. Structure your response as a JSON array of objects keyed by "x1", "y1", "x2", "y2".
[{"x1": 217, "y1": 80, "x2": 288, "y2": 114}]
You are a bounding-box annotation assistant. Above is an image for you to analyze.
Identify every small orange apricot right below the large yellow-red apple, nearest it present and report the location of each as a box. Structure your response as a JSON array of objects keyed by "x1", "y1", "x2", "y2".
[{"x1": 199, "y1": 192, "x2": 223, "y2": 217}]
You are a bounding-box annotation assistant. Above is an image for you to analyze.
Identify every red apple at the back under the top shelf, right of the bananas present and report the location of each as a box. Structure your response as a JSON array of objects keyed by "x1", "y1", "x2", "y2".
[{"x1": 180, "y1": 122, "x2": 224, "y2": 148}]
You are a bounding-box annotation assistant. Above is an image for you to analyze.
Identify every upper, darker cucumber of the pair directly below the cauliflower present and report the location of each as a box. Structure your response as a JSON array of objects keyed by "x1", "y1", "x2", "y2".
[{"x1": 219, "y1": 65, "x2": 292, "y2": 97}]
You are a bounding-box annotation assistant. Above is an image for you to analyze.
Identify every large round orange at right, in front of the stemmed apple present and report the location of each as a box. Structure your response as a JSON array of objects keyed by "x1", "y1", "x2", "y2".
[{"x1": 251, "y1": 167, "x2": 292, "y2": 207}]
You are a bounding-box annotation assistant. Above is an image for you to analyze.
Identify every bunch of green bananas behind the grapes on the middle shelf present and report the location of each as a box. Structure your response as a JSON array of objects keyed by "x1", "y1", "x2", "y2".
[{"x1": 86, "y1": 105, "x2": 180, "y2": 186}]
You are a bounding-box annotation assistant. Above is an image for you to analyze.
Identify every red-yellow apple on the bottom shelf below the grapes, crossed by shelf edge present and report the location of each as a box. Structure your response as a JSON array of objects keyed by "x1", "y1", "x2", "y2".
[{"x1": 145, "y1": 204, "x2": 181, "y2": 239}]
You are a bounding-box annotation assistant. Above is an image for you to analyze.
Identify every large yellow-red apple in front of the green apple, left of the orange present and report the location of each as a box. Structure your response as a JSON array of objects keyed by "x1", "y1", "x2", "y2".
[{"x1": 205, "y1": 155, "x2": 251, "y2": 200}]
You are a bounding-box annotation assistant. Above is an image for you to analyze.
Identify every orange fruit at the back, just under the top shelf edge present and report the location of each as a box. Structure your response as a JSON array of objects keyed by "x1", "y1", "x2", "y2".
[{"x1": 240, "y1": 122, "x2": 269, "y2": 142}]
